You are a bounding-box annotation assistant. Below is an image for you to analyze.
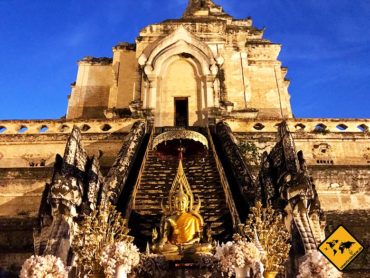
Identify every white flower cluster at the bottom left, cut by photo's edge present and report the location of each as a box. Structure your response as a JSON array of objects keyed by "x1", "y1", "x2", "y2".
[{"x1": 20, "y1": 255, "x2": 68, "y2": 278}]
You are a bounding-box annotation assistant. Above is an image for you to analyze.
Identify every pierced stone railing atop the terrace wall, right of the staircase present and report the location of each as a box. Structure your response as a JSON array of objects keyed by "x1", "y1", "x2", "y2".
[{"x1": 225, "y1": 118, "x2": 370, "y2": 134}]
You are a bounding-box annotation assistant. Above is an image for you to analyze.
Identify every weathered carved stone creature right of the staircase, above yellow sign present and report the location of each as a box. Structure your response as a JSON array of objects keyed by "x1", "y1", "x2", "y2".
[{"x1": 259, "y1": 122, "x2": 325, "y2": 274}]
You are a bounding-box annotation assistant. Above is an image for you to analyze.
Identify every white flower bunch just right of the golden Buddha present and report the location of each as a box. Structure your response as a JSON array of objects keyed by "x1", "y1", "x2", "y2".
[{"x1": 215, "y1": 235, "x2": 261, "y2": 277}]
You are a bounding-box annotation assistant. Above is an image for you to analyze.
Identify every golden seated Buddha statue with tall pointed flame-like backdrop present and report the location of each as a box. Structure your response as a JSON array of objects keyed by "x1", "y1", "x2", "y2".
[{"x1": 153, "y1": 158, "x2": 211, "y2": 255}]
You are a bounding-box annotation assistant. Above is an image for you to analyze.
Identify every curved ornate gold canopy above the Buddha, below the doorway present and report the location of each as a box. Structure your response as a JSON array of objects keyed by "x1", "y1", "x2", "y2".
[{"x1": 153, "y1": 129, "x2": 208, "y2": 149}]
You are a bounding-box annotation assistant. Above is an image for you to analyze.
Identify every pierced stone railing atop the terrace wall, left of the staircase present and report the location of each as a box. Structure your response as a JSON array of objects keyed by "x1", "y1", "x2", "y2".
[{"x1": 0, "y1": 118, "x2": 142, "y2": 136}]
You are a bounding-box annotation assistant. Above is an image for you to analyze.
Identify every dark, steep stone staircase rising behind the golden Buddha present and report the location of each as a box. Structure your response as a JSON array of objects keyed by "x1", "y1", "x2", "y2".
[{"x1": 129, "y1": 142, "x2": 233, "y2": 248}]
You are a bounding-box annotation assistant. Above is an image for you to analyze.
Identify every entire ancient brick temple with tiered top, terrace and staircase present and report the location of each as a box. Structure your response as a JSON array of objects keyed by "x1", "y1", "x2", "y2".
[{"x1": 0, "y1": 0, "x2": 370, "y2": 277}]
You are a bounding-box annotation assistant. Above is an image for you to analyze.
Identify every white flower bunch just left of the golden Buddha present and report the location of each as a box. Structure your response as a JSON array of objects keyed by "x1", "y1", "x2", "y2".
[{"x1": 100, "y1": 241, "x2": 140, "y2": 277}]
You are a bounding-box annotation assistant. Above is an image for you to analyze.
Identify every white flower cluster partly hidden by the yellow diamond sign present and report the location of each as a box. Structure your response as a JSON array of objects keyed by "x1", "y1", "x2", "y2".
[{"x1": 297, "y1": 251, "x2": 342, "y2": 278}]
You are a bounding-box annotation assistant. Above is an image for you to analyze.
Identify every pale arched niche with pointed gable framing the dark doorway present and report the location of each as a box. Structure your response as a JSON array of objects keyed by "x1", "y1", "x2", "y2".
[{"x1": 139, "y1": 27, "x2": 222, "y2": 126}]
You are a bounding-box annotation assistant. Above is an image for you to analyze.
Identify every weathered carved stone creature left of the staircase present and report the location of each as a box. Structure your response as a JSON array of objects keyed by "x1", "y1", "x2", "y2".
[{"x1": 34, "y1": 127, "x2": 95, "y2": 263}]
